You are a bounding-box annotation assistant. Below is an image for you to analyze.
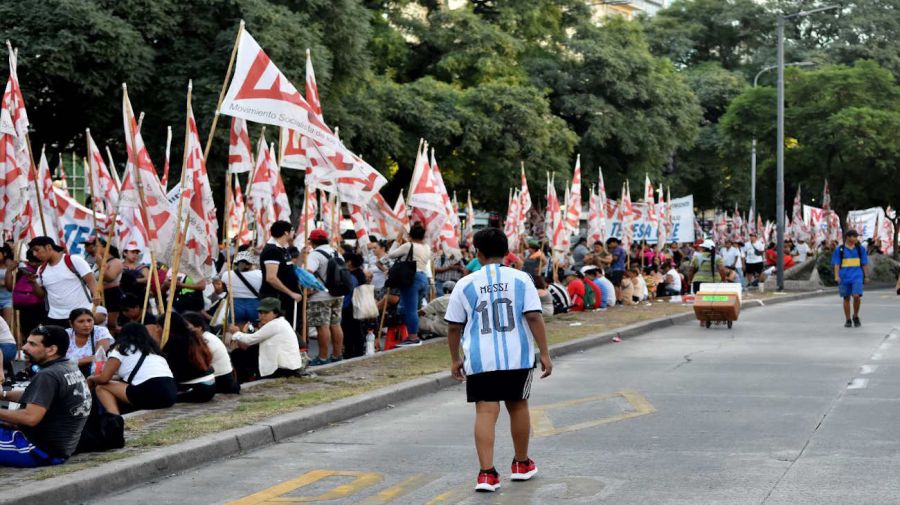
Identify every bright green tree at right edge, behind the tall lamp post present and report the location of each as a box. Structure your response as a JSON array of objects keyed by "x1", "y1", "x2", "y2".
[{"x1": 722, "y1": 61, "x2": 900, "y2": 215}]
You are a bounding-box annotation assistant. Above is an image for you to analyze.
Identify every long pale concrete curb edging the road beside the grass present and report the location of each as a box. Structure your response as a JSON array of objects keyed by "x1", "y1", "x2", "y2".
[{"x1": 0, "y1": 290, "x2": 837, "y2": 504}]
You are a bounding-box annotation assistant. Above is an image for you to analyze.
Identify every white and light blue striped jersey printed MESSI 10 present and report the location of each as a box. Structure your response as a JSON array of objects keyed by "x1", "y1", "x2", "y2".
[{"x1": 444, "y1": 264, "x2": 541, "y2": 375}]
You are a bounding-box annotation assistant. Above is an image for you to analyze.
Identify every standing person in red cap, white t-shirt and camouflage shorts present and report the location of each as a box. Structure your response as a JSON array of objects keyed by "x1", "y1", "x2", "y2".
[{"x1": 306, "y1": 229, "x2": 344, "y2": 366}]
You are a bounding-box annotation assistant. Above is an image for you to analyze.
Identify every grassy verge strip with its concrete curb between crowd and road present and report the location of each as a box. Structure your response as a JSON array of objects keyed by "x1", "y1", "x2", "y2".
[{"x1": 0, "y1": 291, "x2": 830, "y2": 503}]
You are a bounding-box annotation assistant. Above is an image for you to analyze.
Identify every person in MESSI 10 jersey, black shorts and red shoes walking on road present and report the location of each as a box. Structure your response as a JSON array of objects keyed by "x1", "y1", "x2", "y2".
[{"x1": 445, "y1": 228, "x2": 553, "y2": 491}]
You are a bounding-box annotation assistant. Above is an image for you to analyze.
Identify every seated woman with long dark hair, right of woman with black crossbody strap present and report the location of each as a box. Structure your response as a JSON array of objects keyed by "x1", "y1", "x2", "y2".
[{"x1": 160, "y1": 312, "x2": 216, "y2": 403}]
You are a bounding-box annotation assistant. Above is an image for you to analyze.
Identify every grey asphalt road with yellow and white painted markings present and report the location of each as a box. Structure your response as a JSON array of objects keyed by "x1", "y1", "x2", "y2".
[{"x1": 96, "y1": 292, "x2": 900, "y2": 505}]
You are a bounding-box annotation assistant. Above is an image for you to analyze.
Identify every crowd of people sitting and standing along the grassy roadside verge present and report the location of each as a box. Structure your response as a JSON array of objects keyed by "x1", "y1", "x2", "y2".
[{"x1": 0, "y1": 221, "x2": 852, "y2": 466}]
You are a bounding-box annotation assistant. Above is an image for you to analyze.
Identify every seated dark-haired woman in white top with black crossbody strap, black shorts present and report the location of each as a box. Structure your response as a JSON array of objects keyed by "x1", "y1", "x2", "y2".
[{"x1": 87, "y1": 323, "x2": 176, "y2": 414}]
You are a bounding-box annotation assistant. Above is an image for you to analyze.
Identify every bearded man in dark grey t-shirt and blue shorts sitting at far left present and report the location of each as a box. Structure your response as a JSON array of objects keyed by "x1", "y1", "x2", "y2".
[{"x1": 0, "y1": 325, "x2": 91, "y2": 467}]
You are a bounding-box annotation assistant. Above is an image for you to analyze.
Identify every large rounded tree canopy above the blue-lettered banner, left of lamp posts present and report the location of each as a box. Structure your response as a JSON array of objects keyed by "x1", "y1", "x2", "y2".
[{"x1": 531, "y1": 19, "x2": 701, "y2": 193}]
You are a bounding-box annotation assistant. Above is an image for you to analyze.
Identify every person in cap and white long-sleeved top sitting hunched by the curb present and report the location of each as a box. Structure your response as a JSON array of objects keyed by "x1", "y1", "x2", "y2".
[{"x1": 229, "y1": 297, "x2": 304, "y2": 382}]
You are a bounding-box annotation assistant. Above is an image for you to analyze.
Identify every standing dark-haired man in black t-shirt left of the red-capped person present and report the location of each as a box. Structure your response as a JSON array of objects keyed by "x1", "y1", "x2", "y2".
[{"x1": 259, "y1": 221, "x2": 303, "y2": 340}]
